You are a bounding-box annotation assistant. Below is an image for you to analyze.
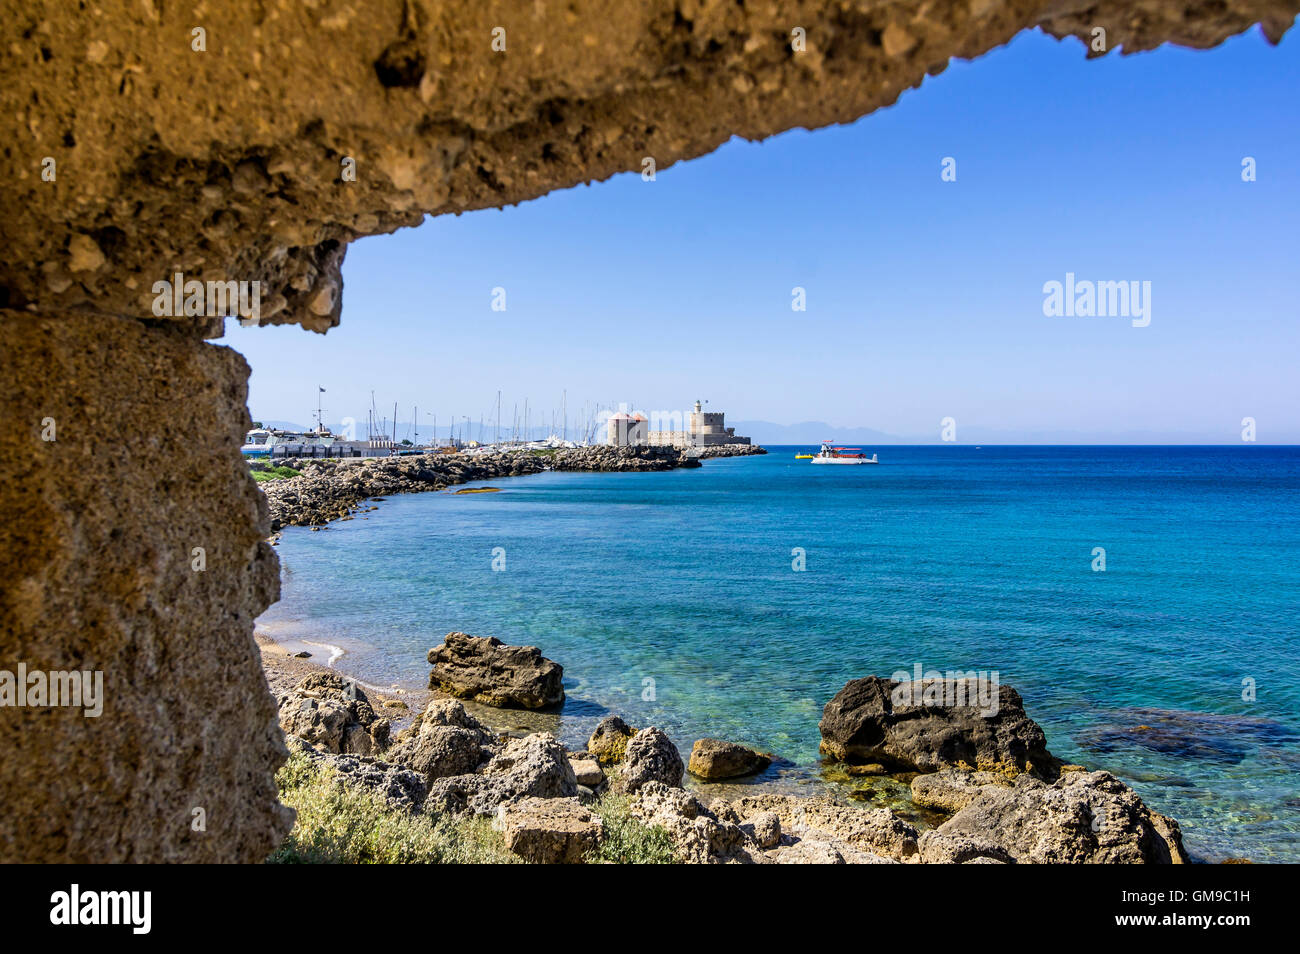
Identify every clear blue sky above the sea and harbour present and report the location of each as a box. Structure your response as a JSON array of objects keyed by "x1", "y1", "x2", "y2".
[{"x1": 222, "y1": 30, "x2": 1300, "y2": 443}]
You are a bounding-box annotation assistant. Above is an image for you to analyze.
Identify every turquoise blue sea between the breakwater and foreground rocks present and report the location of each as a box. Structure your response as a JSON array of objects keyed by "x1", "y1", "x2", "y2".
[{"x1": 259, "y1": 446, "x2": 1300, "y2": 862}]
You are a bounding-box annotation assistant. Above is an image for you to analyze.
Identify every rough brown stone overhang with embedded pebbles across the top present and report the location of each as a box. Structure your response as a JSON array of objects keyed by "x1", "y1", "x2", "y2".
[{"x1": 0, "y1": 0, "x2": 1297, "y2": 330}]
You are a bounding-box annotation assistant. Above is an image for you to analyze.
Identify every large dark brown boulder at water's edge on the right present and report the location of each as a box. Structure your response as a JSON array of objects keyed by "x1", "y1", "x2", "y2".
[{"x1": 819, "y1": 676, "x2": 1061, "y2": 777}]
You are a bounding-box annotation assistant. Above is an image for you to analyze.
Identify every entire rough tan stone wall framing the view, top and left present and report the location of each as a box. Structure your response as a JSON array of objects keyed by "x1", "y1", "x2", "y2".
[{"x1": 0, "y1": 0, "x2": 1300, "y2": 862}]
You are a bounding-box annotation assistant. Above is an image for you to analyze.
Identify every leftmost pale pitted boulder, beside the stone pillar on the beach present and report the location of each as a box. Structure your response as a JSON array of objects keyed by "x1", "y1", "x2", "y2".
[{"x1": 278, "y1": 672, "x2": 393, "y2": 755}]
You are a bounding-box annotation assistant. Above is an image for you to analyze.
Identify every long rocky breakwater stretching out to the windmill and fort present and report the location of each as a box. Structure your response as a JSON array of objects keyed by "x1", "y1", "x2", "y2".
[{"x1": 260, "y1": 445, "x2": 767, "y2": 532}]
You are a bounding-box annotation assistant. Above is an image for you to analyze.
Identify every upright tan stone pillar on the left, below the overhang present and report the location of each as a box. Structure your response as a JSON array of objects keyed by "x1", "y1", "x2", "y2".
[{"x1": 0, "y1": 315, "x2": 293, "y2": 863}]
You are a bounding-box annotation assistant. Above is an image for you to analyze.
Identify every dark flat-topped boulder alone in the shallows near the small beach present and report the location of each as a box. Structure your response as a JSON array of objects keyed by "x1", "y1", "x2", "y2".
[{"x1": 429, "y1": 633, "x2": 564, "y2": 710}]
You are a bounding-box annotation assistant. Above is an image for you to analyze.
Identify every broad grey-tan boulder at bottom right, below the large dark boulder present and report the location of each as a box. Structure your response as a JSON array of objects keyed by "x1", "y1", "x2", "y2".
[{"x1": 919, "y1": 772, "x2": 1187, "y2": 864}]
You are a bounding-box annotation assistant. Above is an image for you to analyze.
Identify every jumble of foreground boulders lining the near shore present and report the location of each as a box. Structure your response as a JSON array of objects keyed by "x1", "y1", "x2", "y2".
[{"x1": 264, "y1": 633, "x2": 1188, "y2": 864}]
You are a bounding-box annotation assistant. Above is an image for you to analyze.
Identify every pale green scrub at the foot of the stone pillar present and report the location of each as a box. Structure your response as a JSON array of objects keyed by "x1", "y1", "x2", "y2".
[{"x1": 267, "y1": 753, "x2": 519, "y2": 864}]
